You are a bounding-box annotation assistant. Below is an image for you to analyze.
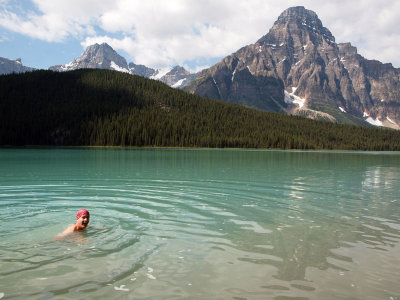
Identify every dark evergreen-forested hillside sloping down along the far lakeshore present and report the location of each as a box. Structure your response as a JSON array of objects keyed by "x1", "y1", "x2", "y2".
[{"x1": 0, "y1": 70, "x2": 400, "y2": 151}]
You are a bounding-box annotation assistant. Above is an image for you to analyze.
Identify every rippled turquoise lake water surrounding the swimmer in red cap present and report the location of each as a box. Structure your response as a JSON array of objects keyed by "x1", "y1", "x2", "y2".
[{"x1": 0, "y1": 149, "x2": 400, "y2": 300}]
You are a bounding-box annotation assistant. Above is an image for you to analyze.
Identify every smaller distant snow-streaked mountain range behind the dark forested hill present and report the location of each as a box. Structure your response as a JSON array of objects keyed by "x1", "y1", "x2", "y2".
[{"x1": 49, "y1": 43, "x2": 197, "y2": 88}]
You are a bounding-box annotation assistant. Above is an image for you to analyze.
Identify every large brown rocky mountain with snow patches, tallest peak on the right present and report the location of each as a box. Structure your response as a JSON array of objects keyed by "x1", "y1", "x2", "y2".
[{"x1": 187, "y1": 6, "x2": 400, "y2": 129}]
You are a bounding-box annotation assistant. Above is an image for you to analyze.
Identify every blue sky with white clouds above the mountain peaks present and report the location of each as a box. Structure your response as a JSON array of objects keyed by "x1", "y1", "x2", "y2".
[{"x1": 0, "y1": 0, "x2": 400, "y2": 72}]
